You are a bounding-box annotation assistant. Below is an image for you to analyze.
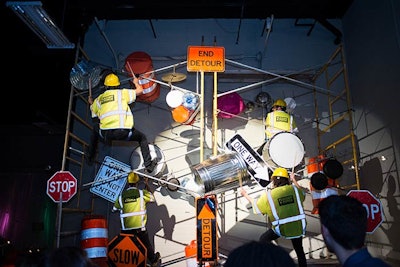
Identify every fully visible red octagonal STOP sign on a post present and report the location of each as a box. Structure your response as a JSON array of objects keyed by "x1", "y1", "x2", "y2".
[{"x1": 46, "y1": 171, "x2": 78, "y2": 202}]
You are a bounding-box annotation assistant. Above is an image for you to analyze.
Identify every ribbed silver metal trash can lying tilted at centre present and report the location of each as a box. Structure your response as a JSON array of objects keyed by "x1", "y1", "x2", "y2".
[{"x1": 193, "y1": 153, "x2": 250, "y2": 194}]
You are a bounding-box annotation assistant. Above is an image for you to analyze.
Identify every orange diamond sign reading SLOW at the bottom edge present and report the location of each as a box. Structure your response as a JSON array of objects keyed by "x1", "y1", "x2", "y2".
[{"x1": 108, "y1": 234, "x2": 147, "y2": 267}]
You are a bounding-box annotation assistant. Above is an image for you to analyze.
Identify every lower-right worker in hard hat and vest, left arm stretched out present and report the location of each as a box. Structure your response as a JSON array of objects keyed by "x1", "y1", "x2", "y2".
[{"x1": 241, "y1": 168, "x2": 307, "y2": 267}]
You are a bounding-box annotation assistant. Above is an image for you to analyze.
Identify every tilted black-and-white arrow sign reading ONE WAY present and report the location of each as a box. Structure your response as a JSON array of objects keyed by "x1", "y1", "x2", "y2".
[{"x1": 225, "y1": 134, "x2": 270, "y2": 187}]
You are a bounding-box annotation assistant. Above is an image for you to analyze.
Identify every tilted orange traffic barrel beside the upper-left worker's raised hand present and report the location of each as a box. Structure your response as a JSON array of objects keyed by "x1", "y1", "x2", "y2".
[{"x1": 125, "y1": 51, "x2": 160, "y2": 103}]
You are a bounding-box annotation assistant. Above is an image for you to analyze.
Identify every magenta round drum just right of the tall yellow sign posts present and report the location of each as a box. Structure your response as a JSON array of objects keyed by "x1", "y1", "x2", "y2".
[{"x1": 217, "y1": 92, "x2": 245, "y2": 119}]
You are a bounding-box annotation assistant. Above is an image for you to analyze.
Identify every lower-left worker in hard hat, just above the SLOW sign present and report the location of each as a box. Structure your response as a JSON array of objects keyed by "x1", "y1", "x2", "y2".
[{"x1": 113, "y1": 172, "x2": 160, "y2": 267}]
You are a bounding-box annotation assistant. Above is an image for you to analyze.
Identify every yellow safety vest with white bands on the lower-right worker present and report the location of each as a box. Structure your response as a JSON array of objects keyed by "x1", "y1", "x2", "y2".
[{"x1": 267, "y1": 185, "x2": 306, "y2": 239}]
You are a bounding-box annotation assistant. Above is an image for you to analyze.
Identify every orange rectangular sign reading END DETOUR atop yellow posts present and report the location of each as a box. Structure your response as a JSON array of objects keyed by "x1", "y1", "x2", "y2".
[{"x1": 187, "y1": 46, "x2": 225, "y2": 72}]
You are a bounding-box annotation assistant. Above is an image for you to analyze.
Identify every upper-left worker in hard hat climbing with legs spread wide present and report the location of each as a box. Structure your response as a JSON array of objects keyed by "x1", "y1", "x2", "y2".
[{"x1": 86, "y1": 73, "x2": 157, "y2": 173}]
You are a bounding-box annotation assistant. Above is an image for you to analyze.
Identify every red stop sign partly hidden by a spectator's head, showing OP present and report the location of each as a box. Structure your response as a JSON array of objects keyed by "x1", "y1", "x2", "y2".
[{"x1": 347, "y1": 190, "x2": 383, "y2": 233}]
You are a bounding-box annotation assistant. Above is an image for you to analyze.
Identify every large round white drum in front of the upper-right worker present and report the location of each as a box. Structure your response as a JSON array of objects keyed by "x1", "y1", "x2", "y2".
[{"x1": 262, "y1": 132, "x2": 304, "y2": 168}]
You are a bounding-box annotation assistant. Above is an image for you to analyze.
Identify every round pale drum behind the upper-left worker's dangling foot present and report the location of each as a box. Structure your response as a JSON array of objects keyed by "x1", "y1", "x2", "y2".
[{"x1": 130, "y1": 144, "x2": 166, "y2": 176}]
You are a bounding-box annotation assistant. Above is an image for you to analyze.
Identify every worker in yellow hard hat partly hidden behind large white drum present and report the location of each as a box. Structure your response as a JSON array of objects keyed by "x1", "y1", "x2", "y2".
[{"x1": 257, "y1": 99, "x2": 299, "y2": 155}]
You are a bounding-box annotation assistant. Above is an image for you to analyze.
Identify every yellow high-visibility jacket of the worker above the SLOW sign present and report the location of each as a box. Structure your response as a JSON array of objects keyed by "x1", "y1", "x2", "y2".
[{"x1": 113, "y1": 187, "x2": 154, "y2": 230}]
